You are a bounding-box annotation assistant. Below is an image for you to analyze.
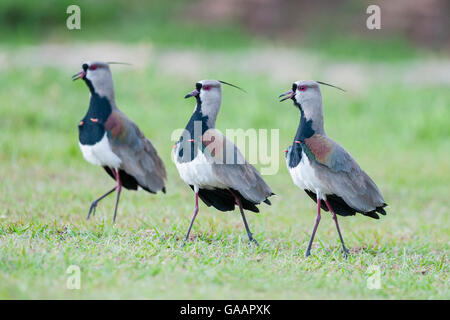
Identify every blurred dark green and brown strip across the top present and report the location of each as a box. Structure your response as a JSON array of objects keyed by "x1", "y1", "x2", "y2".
[{"x1": 0, "y1": 0, "x2": 450, "y2": 59}]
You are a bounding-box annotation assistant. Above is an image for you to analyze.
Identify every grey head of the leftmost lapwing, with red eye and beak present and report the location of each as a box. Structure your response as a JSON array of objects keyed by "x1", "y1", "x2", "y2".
[{"x1": 72, "y1": 61, "x2": 114, "y2": 99}]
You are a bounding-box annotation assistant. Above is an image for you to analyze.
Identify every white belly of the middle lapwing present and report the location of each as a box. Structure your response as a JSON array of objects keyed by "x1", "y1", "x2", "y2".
[{"x1": 173, "y1": 148, "x2": 227, "y2": 189}]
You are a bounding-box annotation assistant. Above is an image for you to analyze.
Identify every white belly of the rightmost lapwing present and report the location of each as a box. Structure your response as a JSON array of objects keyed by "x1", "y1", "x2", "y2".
[{"x1": 288, "y1": 152, "x2": 329, "y2": 197}]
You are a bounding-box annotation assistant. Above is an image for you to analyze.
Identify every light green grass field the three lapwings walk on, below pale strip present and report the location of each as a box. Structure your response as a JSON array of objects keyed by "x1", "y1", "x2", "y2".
[{"x1": 0, "y1": 61, "x2": 450, "y2": 299}]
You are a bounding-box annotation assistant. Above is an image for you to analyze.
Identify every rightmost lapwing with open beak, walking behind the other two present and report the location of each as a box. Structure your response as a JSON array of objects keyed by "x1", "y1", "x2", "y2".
[{"x1": 280, "y1": 80, "x2": 386, "y2": 257}]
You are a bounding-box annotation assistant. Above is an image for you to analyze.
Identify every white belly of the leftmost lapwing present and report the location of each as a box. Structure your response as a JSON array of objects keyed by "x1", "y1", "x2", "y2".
[{"x1": 79, "y1": 132, "x2": 122, "y2": 169}]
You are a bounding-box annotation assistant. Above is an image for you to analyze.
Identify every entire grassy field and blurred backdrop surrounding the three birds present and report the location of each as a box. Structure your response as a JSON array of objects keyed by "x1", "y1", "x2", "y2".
[{"x1": 0, "y1": 0, "x2": 450, "y2": 299}]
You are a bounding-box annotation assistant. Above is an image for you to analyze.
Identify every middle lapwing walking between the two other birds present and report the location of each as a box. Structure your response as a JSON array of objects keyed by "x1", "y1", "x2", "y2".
[{"x1": 172, "y1": 80, "x2": 273, "y2": 245}]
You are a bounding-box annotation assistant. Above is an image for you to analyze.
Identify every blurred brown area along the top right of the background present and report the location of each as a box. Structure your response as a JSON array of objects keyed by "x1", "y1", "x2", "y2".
[{"x1": 187, "y1": 0, "x2": 450, "y2": 50}]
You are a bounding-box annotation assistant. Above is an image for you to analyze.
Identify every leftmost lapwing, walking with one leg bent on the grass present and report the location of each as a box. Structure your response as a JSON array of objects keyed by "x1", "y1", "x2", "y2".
[{"x1": 72, "y1": 62, "x2": 166, "y2": 222}]
